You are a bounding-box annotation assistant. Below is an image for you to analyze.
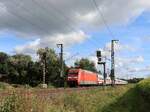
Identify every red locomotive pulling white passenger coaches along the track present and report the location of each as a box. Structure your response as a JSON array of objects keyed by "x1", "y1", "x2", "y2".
[{"x1": 67, "y1": 69, "x2": 127, "y2": 87}]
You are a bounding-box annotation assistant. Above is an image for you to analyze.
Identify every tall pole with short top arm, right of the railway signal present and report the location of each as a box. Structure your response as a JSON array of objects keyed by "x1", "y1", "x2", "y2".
[{"x1": 110, "y1": 40, "x2": 119, "y2": 85}]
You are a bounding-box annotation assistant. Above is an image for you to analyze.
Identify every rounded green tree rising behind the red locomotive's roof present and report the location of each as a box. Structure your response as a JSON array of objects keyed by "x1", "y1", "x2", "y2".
[{"x1": 74, "y1": 58, "x2": 97, "y2": 72}]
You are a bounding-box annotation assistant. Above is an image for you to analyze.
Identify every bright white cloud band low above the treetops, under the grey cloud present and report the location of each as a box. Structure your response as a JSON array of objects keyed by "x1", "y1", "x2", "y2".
[{"x1": 15, "y1": 31, "x2": 89, "y2": 54}]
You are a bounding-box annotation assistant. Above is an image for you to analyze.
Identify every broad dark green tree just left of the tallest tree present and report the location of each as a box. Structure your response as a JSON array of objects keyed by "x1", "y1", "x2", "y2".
[{"x1": 8, "y1": 54, "x2": 32, "y2": 84}]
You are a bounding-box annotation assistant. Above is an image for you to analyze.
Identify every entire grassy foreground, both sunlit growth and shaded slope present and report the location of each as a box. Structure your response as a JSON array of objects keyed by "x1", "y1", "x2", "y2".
[{"x1": 0, "y1": 79, "x2": 150, "y2": 112}]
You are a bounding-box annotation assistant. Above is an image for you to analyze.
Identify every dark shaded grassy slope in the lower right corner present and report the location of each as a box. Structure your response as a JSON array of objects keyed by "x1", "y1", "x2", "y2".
[{"x1": 102, "y1": 79, "x2": 150, "y2": 112}]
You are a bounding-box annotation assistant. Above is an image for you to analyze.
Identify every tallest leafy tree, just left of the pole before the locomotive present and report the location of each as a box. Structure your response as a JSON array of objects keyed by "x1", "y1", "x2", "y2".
[{"x1": 37, "y1": 48, "x2": 64, "y2": 85}]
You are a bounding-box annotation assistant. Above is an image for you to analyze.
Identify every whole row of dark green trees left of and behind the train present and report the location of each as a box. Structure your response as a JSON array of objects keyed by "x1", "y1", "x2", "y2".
[{"x1": 0, "y1": 48, "x2": 97, "y2": 86}]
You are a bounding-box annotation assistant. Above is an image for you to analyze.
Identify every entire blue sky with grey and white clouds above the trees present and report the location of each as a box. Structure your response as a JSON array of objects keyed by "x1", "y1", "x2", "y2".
[{"x1": 0, "y1": 0, "x2": 150, "y2": 77}]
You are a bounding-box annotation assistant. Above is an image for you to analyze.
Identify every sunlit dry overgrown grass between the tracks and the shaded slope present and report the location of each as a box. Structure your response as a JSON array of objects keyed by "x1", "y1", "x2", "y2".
[{"x1": 0, "y1": 85, "x2": 131, "y2": 112}]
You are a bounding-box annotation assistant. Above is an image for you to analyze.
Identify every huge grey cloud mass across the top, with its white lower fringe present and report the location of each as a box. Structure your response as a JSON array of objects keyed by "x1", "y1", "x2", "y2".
[{"x1": 0, "y1": 0, "x2": 150, "y2": 52}]
